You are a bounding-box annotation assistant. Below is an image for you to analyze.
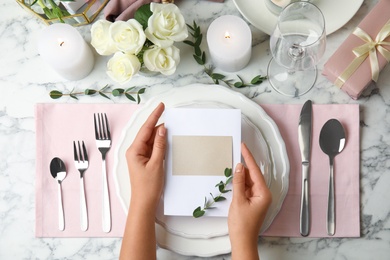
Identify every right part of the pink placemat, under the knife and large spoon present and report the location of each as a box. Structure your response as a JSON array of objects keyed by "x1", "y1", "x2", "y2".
[{"x1": 261, "y1": 105, "x2": 360, "y2": 237}]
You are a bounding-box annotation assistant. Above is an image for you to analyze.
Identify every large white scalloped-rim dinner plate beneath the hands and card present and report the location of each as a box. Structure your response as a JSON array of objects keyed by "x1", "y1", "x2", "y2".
[{"x1": 114, "y1": 84, "x2": 289, "y2": 256}]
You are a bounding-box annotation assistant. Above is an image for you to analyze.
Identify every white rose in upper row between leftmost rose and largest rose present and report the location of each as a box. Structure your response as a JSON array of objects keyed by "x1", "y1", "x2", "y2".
[{"x1": 109, "y1": 19, "x2": 146, "y2": 54}]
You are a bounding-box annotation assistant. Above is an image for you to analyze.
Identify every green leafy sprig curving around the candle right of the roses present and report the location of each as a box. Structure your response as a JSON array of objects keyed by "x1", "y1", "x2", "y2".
[{"x1": 183, "y1": 21, "x2": 267, "y2": 88}]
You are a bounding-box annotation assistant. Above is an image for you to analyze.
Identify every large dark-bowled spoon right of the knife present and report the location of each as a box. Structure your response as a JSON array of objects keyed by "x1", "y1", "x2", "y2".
[{"x1": 320, "y1": 119, "x2": 345, "y2": 236}]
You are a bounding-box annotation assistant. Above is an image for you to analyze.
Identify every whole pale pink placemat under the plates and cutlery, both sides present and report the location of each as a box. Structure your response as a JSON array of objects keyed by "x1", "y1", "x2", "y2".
[{"x1": 35, "y1": 104, "x2": 360, "y2": 237}]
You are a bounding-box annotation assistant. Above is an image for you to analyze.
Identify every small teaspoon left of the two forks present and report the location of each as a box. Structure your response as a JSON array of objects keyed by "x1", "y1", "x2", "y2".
[{"x1": 50, "y1": 157, "x2": 66, "y2": 230}]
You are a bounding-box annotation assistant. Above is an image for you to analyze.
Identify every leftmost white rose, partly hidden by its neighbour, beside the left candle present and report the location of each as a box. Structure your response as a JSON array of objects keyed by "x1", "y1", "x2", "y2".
[{"x1": 91, "y1": 20, "x2": 117, "y2": 55}]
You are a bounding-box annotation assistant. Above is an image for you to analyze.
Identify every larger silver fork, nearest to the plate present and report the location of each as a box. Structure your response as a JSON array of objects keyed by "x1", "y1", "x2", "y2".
[{"x1": 93, "y1": 113, "x2": 111, "y2": 233}]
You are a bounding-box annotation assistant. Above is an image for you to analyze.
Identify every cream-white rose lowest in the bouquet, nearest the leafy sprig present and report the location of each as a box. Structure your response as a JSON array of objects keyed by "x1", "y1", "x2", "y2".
[{"x1": 107, "y1": 52, "x2": 141, "y2": 84}]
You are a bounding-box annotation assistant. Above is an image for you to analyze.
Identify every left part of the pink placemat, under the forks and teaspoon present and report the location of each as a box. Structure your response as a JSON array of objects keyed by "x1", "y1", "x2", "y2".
[{"x1": 35, "y1": 104, "x2": 137, "y2": 237}]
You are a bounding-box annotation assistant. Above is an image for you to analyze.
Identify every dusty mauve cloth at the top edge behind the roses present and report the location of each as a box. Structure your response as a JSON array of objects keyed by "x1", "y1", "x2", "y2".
[{"x1": 104, "y1": 0, "x2": 224, "y2": 22}]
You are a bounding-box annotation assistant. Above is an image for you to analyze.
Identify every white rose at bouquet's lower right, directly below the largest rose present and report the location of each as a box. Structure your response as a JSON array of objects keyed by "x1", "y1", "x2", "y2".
[{"x1": 143, "y1": 45, "x2": 180, "y2": 76}]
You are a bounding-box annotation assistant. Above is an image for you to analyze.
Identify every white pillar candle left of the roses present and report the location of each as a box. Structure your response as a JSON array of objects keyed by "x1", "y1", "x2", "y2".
[{"x1": 38, "y1": 23, "x2": 94, "y2": 80}]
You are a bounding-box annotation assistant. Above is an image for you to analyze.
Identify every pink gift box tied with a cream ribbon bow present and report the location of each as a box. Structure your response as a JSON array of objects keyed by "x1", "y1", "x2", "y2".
[{"x1": 322, "y1": 0, "x2": 390, "y2": 99}]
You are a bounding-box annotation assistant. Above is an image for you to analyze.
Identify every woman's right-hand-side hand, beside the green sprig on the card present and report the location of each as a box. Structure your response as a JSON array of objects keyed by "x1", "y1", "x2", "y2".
[{"x1": 228, "y1": 144, "x2": 272, "y2": 259}]
